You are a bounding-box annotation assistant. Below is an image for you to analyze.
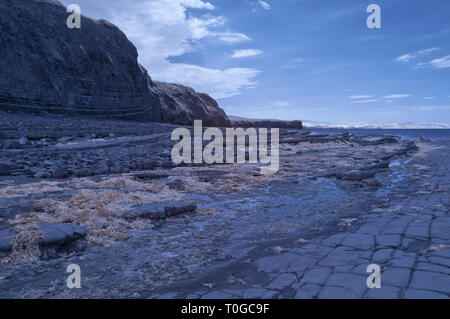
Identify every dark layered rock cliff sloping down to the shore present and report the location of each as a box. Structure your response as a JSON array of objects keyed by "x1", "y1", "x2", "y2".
[{"x1": 0, "y1": 0, "x2": 229, "y2": 126}]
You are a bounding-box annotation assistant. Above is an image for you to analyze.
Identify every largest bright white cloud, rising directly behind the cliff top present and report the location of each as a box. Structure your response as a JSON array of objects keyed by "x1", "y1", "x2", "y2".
[{"x1": 95, "y1": 0, "x2": 260, "y2": 98}]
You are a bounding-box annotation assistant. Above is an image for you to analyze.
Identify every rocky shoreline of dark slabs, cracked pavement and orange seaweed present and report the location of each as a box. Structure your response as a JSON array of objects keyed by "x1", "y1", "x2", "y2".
[{"x1": 0, "y1": 113, "x2": 450, "y2": 298}]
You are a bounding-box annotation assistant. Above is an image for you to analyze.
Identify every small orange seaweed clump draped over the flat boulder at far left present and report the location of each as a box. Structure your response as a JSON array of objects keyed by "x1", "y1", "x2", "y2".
[{"x1": 0, "y1": 223, "x2": 44, "y2": 264}]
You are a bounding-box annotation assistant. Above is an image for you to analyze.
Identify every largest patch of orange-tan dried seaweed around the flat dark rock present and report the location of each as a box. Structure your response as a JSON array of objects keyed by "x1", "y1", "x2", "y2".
[{"x1": 9, "y1": 179, "x2": 182, "y2": 246}]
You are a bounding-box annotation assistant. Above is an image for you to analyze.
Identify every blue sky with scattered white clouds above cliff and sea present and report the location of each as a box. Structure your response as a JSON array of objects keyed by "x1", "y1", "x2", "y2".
[{"x1": 62, "y1": 0, "x2": 450, "y2": 124}]
